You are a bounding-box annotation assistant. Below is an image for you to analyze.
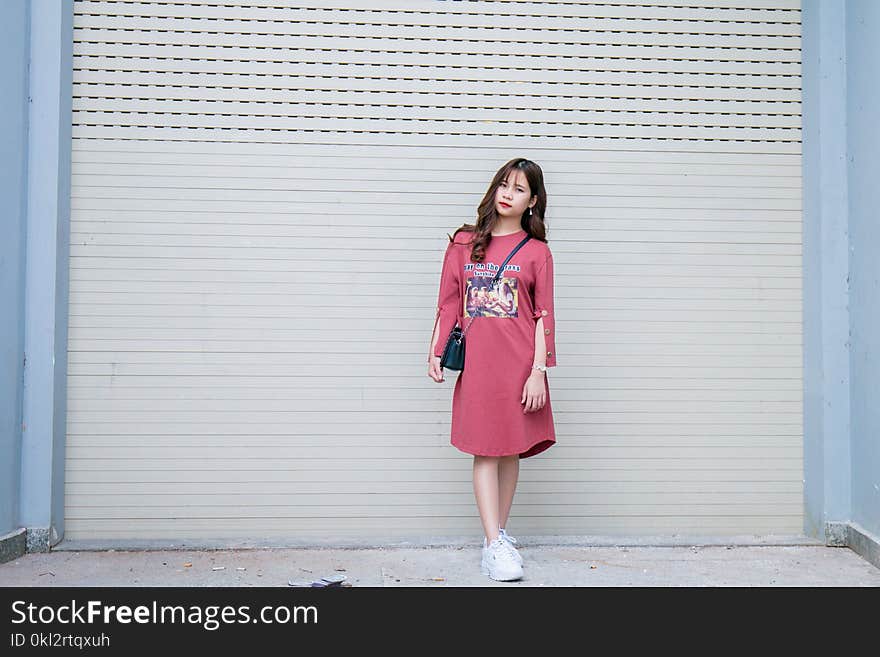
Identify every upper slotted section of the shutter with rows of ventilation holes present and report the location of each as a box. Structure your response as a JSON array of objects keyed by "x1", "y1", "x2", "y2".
[{"x1": 74, "y1": 0, "x2": 801, "y2": 151}]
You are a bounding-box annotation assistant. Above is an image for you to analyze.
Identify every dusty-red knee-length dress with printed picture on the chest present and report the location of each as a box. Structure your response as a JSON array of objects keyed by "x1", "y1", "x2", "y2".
[{"x1": 434, "y1": 229, "x2": 556, "y2": 459}]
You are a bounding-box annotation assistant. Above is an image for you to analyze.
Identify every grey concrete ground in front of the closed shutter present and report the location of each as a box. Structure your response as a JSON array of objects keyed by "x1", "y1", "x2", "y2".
[{"x1": 0, "y1": 536, "x2": 880, "y2": 587}]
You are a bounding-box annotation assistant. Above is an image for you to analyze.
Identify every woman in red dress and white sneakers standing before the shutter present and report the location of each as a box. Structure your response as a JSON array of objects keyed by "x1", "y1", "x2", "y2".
[{"x1": 428, "y1": 158, "x2": 556, "y2": 581}]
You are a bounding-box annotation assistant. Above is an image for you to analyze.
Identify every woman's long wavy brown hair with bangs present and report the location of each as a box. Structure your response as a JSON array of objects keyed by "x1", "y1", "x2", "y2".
[{"x1": 447, "y1": 157, "x2": 547, "y2": 262}]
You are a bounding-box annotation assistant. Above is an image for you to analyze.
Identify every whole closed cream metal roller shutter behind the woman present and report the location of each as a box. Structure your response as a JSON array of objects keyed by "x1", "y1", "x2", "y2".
[{"x1": 66, "y1": 0, "x2": 803, "y2": 542}]
